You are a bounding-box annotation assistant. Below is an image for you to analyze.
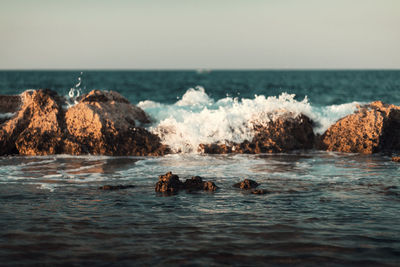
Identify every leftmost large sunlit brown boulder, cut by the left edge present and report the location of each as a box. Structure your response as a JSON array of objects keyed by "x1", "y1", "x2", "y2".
[{"x1": 0, "y1": 89, "x2": 63, "y2": 155}]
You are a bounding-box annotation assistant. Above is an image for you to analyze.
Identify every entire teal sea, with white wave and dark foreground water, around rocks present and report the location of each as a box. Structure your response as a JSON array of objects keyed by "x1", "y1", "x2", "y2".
[{"x1": 0, "y1": 69, "x2": 400, "y2": 266}]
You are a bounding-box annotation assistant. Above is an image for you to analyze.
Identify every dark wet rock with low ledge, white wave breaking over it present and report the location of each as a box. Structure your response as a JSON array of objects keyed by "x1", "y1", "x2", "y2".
[{"x1": 199, "y1": 113, "x2": 315, "y2": 154}]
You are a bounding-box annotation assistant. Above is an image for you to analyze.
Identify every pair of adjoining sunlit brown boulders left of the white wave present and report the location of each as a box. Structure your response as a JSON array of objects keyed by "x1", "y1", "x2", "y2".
[{"x1": 0, "y1": 90, "x2": 169, "y2": 155}]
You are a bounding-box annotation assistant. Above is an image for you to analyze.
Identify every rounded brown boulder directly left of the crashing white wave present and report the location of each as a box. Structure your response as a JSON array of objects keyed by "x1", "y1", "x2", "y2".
[{"x1": 64, "y1": 90, "x2": 169, "y2": 156}]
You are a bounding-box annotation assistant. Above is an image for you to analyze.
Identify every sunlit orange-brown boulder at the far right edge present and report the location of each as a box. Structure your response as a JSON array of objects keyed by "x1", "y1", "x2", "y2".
[{"x1": 319, "y1": 101, "x2": 400, "y2": 154}]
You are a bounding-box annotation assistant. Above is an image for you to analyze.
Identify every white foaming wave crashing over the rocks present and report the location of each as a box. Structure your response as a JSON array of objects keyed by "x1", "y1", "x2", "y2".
[{"x1": 138, "y1": 86, "x2": 360, "y2": 153}]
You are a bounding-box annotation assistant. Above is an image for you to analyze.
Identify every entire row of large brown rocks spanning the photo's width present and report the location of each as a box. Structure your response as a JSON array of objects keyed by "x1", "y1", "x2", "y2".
[{"x1": 0, "y1": 89, "x2": 400, "y2": 156}]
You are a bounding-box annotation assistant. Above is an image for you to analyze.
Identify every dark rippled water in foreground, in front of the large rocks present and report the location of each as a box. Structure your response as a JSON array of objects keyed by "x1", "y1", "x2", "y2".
[{"x1": 0, "y1": 152, "x2": 400, "y2": 266}]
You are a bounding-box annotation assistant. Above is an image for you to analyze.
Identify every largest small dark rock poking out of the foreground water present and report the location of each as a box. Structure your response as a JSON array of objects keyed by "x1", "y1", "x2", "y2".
[{"x1": 155, "y1": 172, "x2": 218, "y2": 194}]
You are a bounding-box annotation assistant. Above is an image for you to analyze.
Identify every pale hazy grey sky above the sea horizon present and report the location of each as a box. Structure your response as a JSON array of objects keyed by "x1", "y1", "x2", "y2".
[{"x1": 0, "y1": 0, "x2": 400, "y2": 69}]
